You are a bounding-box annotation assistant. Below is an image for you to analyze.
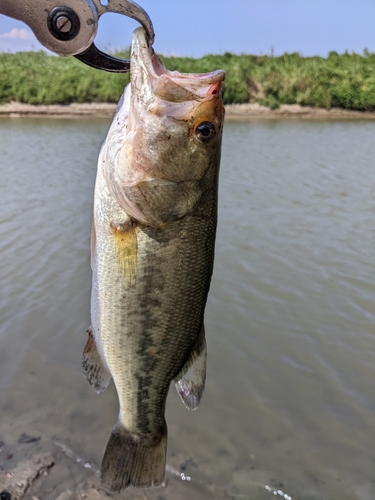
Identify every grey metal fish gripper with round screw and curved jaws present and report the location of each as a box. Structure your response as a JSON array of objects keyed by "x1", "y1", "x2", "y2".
[{"x1": 0, "y1": 0, "x2": 155, "y2": 73}]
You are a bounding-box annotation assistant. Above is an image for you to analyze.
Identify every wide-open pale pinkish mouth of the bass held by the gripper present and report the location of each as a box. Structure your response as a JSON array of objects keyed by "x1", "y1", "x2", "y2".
[{"x1": 131, "y1": 28, "x2": 225, "y2": 105}]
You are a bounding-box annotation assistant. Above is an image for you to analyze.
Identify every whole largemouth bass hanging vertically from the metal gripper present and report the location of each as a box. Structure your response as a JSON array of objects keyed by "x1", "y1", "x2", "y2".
[{"x1": 82, "y1": 28, "x2": 225, "y2": 492}]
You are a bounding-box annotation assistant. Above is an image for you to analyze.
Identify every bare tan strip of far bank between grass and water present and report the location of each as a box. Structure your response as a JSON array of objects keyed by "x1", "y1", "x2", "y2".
[{"x1": 0, "y1": 102, "x2": 375, "y2": 120}]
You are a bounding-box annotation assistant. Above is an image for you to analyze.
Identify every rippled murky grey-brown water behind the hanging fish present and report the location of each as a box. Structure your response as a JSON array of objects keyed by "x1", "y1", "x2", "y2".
[{"x1": 0, "y1": 119, "x2": 375, "y2": 500}]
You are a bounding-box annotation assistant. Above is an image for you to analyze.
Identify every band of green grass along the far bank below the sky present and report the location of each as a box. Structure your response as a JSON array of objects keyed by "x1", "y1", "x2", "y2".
[{"x1": 0, "y1": 50, "x2": 375, "y2": 111}]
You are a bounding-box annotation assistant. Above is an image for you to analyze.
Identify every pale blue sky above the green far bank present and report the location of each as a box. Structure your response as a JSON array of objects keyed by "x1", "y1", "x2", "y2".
[{"x1": 0, "y1": 0, "x2": 375, "y2": 57}]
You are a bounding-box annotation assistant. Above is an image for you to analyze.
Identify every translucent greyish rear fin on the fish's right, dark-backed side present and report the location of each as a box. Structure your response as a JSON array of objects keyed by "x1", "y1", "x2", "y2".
[{"x1": 175, "y1": 325, "x2": 207, "y2": 410}]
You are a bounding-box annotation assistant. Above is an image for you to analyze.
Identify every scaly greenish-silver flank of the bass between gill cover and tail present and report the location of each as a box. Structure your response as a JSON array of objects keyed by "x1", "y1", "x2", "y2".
[{"x1": 93, "y1": 164, "x2": 216, "y2": 431}]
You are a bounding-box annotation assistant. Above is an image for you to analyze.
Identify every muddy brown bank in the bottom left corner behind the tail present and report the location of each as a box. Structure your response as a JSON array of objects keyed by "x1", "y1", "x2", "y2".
[{"x1": 0, "y1": 433, "x2": 234, "y2": 500}]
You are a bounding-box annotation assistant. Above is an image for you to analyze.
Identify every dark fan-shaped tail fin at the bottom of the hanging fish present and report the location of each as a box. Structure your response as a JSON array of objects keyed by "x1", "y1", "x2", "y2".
[{"x1": 100, "y1": 420, "x2": 167, "y2": 493}]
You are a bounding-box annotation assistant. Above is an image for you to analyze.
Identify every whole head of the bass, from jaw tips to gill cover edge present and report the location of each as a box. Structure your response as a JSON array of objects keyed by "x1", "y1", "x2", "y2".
[{"x1": 106, "y1": 28, "x2": 225, "y2": 228}]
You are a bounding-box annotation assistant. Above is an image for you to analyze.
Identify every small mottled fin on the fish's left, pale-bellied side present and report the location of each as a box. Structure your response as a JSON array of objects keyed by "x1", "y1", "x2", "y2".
[{"x1": 82, "y1": 326, "x2": 111, "y2": 394}]
